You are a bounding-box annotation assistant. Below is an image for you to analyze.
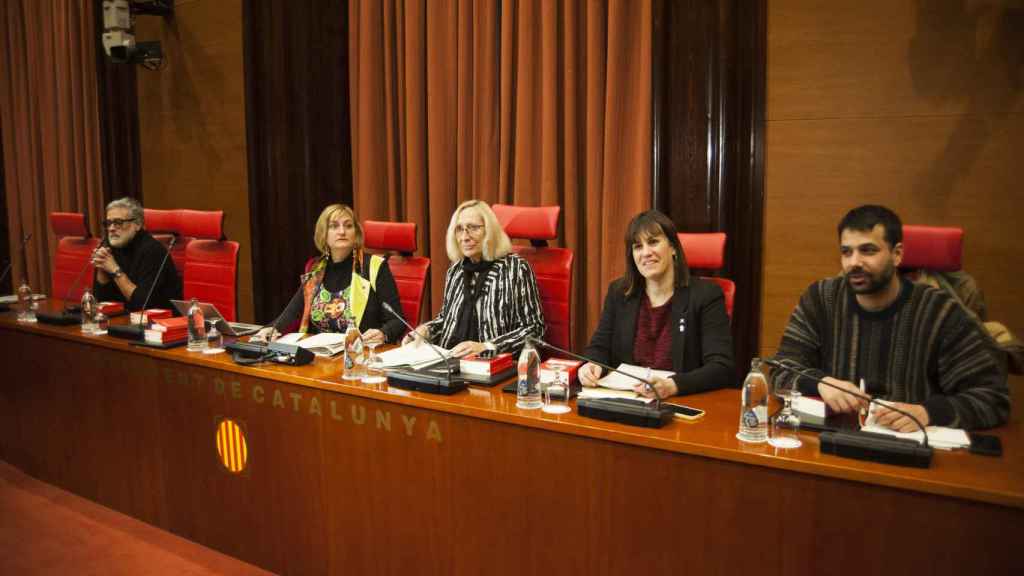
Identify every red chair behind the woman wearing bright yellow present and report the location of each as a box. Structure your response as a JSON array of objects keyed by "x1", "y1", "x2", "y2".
[{"x1": 362, "y1": 220, "x2": 430, "y2": 326}]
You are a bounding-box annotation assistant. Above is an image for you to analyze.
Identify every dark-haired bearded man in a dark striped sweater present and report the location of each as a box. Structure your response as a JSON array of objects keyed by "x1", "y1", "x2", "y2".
[{"x1": 773, "y1": 205, "x2": 1010, "y2": 431}]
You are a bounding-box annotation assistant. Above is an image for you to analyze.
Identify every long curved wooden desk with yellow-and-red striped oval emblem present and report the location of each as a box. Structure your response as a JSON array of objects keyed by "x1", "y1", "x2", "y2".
[{"x1": 0, "y1": 303, "x2": 1024, "y2": 576}]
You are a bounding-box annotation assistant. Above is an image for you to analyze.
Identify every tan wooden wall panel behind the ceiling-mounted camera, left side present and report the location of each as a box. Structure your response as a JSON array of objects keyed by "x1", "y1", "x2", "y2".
[{"x1": 136, "y1": 0, "x2": 253, "y2": 321}]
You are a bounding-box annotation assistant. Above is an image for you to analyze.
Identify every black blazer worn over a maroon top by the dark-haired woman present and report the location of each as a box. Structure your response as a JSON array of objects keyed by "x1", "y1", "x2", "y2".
[{"x1": 586, "y1": 277, "x2": 736, "y2": 394}]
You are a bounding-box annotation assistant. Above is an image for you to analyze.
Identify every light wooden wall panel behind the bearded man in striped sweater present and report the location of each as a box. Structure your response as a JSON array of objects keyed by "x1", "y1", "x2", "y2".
[{"x1": 761, "y1": 0, "x2": 1024, "y2": 355}]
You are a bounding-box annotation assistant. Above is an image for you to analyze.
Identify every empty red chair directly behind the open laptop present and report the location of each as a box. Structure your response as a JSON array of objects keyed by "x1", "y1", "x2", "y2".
[{"x1": 177, "y1": 210, "x2": 239, "y2": 322}]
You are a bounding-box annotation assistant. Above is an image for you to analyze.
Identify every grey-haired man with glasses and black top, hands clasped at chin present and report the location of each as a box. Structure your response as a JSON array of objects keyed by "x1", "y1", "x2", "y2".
[{"x1": 92, "y1": 198, "x2": 181, "y2": 311}]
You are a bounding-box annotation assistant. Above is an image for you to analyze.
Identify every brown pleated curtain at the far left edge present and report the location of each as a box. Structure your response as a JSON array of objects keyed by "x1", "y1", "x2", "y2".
[{"x1": 0, "y1": 0, "x2": 103, "y2": 291}]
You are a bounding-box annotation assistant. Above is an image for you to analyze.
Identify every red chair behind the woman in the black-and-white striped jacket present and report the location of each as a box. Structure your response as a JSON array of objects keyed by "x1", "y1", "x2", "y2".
[{"x1": 492, "y1": 204, "x2": 574, "y2": 349}]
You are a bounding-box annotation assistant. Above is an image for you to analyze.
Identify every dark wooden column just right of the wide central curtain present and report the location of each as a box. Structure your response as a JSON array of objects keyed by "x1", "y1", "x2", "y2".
[{"x1": 651, "y1": 0, "x2": 767, "y2": 374}]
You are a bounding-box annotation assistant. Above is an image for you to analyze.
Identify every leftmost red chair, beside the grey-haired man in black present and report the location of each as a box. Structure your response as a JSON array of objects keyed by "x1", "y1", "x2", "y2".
[{"x1": 50, "y1": 212, "x2": 99, "y2": 301}]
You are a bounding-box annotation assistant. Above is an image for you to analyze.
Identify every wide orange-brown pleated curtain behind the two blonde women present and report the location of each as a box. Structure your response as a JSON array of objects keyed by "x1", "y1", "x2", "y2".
[{"x1": 349, "y1": 0, "x2": 651, "y2": 348}]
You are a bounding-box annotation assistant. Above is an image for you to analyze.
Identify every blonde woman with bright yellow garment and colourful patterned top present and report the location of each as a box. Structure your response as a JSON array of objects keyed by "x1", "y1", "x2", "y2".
[{"x1": 254, "y1": 204, "x2": 404, "y2": 343}]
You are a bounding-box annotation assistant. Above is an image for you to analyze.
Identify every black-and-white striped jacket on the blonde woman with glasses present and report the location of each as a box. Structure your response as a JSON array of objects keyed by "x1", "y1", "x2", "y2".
[{"x1": 427, "y1": 253, "x2": 545, "y2": 354}]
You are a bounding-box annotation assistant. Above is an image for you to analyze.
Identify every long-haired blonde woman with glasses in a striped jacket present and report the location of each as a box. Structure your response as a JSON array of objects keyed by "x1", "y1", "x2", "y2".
[{"x1": 407, "y1": 200, "x2": 544, "y2": 357}]
